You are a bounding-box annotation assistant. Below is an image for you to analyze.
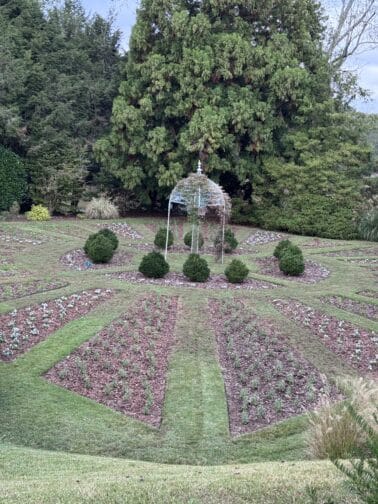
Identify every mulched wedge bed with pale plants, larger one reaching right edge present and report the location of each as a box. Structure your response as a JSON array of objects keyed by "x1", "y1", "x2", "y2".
[{"x1": 273, "y1": 299, "x2": 378, "y2": 376}]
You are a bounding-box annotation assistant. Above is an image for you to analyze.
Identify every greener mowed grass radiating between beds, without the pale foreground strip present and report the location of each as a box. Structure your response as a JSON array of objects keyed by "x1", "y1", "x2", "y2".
[{"x1": 0, "y1": 218, "x2": 378, "y2": 480}]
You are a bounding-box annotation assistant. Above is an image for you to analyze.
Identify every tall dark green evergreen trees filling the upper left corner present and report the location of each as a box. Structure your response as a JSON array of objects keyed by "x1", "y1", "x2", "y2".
[{"x1": 0, "y1": 0, "x2": 120, "y2": 212}]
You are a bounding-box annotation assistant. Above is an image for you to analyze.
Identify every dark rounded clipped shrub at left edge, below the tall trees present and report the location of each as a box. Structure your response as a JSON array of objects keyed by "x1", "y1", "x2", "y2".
[{"x1": 0, "y1": 145, "x2": 26, "y2": 211}]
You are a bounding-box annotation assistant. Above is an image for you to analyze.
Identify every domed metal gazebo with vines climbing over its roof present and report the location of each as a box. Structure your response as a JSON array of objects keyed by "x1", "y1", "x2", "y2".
[{"x1": 165, "y1": 161, "x2": 231, "y2": 264}]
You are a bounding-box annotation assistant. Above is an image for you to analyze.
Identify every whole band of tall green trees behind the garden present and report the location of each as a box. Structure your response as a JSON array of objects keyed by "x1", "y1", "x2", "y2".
[{"x1": 0, "y1": 0, "x2": 378, "y2": 238}]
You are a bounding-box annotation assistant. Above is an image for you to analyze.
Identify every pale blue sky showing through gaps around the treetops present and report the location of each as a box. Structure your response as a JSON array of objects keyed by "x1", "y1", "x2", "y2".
[{"x1": 82, "y1": 0, "x2": 378, "y2": 114}]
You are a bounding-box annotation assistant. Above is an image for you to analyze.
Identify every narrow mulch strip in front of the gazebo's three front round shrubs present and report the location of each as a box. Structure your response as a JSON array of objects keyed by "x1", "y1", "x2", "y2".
[{"x1": 108, "y1": 271, "x2": 279, "y2": 290}]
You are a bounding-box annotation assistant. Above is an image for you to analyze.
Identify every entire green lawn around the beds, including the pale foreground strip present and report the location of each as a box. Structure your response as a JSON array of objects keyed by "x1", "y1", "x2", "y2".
[{"x1": 0, "y1": 218, "x2": 378, "y2": 503}]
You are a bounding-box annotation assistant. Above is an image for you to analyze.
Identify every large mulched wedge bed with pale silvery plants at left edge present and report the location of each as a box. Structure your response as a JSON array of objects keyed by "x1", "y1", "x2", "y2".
[{"x1": 0, "y1": 289, "x2": 113, "y2": 361}]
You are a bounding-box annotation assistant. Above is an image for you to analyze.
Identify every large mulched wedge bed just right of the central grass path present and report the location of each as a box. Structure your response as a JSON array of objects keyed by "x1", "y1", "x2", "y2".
[{"x1": 209, "y1": 299, "x2": 337, "y2": 435}]
